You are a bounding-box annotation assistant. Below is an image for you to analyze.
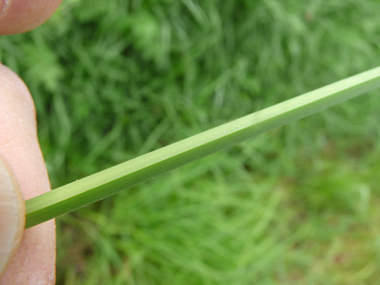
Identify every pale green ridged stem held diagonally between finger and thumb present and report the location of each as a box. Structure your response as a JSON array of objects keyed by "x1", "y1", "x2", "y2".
[{"x1": 26, "y1": 67, "x2": 380, "y2": 228}]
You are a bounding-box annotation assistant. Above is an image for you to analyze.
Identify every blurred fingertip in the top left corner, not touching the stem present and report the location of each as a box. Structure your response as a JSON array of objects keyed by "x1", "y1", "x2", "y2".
[{"x1": 0, "y1": 0, "x2": 62, "y2": 35}]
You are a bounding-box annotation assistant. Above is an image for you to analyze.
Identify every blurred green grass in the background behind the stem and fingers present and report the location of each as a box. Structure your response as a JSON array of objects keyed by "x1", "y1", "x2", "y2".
[{"x1": 0, "y1": 0, "x2": 380, "y2": 284}]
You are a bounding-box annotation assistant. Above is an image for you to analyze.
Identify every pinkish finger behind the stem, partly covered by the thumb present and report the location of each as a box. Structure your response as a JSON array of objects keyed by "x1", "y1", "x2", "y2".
[{"x1": 0, "y1": 65, "x2": 55, "y2": 284}]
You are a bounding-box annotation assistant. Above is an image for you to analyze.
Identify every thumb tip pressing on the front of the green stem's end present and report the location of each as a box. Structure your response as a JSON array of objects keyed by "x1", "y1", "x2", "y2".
[{"x1": 0, "y1": 152, "x2": 25, "y2": 277}]
